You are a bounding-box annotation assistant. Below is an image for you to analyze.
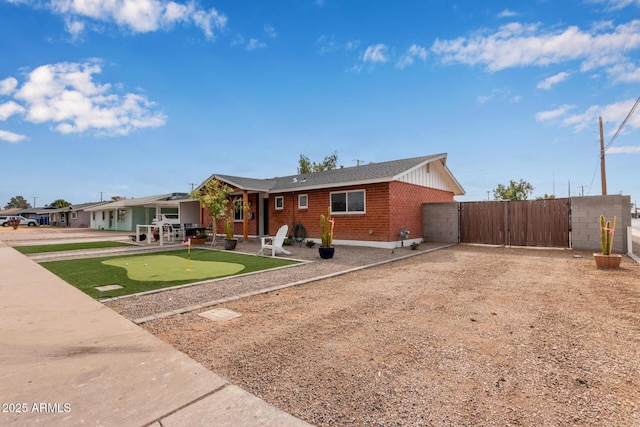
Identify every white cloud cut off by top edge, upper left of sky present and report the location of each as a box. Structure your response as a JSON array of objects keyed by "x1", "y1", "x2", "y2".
[{"x1": 21, "y1": 0, "x2": 227, "y2": 39}]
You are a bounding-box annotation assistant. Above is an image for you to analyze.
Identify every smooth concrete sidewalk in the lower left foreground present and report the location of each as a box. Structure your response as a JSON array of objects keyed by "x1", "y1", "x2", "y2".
[{"x1": 0, "y1": 242, "x2": 308, "y2": 426}]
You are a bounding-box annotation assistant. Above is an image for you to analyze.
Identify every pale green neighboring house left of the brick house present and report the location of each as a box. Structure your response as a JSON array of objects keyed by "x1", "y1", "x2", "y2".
[{"x1": 86, "y1": 193, "x2": 200, "y2": 231}]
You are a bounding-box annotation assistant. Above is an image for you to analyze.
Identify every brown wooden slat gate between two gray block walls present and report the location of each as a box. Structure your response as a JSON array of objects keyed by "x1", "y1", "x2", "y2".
[{"x1": 460, "y1": 199, "x2": 571, "y2": 248}]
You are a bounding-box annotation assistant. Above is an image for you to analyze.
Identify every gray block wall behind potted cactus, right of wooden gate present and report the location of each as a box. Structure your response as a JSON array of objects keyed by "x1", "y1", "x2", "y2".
[{"x1": 571, "y1": 195, "x2": 631, "y2": 253}]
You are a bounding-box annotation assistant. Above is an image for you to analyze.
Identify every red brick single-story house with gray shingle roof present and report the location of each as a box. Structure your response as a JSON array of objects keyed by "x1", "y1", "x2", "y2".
[{"x1": 200, "y1": 154, "x2": 465, "y2": 248}]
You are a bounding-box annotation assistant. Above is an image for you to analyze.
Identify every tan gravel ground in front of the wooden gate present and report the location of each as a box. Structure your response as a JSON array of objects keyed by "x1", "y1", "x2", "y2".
[{"x1": 144, "y1": 246, "x2": 640, "y2": 426}]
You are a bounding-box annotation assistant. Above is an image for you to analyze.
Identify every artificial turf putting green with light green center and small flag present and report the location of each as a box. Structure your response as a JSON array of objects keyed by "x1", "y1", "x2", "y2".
[{"x1": 41, "y1": 249, "x2": 297, "y2": 298}]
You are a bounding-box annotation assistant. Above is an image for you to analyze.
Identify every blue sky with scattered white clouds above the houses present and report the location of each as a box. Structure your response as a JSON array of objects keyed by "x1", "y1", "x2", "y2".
[{"x1": 0, "y1": 0, "x2": 640, "y2": 207}]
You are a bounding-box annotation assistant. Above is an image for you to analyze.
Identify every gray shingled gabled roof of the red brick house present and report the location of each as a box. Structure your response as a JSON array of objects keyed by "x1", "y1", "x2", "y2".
[{"x1": 201, "y1": 153, "x2": 465, "y2": 195}]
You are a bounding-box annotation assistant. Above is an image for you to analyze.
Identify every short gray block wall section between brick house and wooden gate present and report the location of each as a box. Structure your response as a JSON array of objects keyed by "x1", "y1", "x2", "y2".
[{"x1": 422, "y1": 202, "x2": 459, "y2": 243}]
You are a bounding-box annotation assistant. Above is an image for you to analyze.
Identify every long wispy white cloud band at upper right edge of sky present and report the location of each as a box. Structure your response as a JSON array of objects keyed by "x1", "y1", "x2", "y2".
[{"x1": 431, "y1": 21, "x2": 640, "y2": 80}]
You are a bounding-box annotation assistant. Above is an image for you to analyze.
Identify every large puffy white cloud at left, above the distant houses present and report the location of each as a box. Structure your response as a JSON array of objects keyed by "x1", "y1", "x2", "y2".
[{"x1": 7, "y1": 62, "x2": 166, "y2": 135}]
